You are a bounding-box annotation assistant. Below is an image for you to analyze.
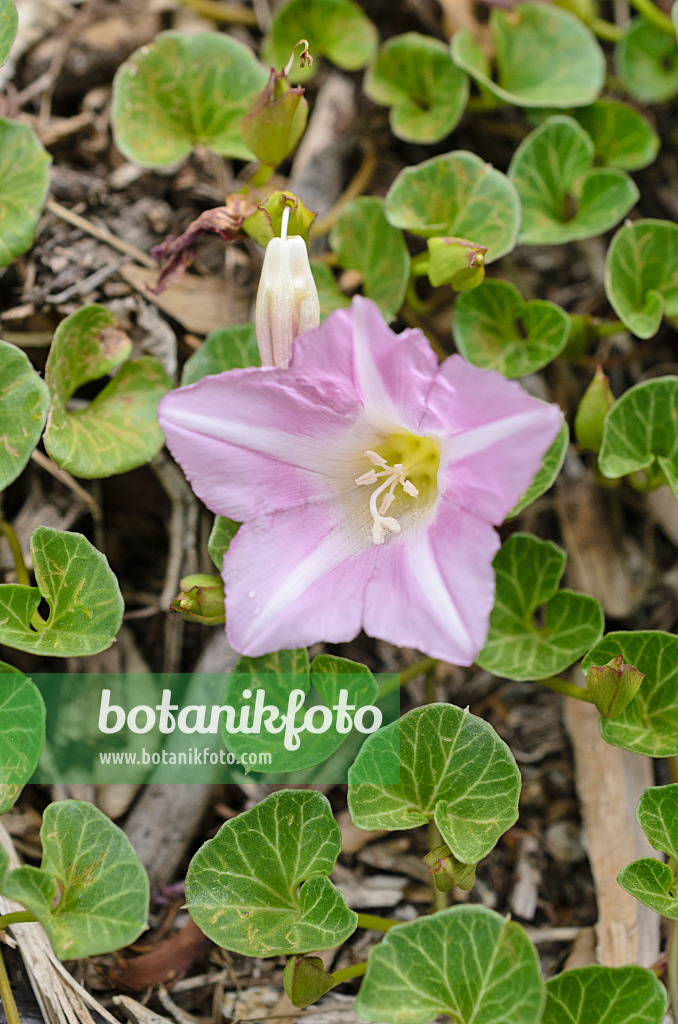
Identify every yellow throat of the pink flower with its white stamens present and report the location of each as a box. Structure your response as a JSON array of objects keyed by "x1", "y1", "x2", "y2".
[{"x1": 355, "y1": 430, "x2": 440, "y2": 544}]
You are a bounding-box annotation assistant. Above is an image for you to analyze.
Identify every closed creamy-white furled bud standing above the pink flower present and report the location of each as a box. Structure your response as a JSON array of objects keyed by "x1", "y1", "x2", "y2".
[{"x1": 254, "y1": 207, "x2": 321, "y2": 367}]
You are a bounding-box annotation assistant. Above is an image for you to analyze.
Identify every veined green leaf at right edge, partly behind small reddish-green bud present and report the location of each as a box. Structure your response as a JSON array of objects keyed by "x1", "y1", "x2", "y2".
[{"x1": 582, "y1": 630, "x2": 678, "y2": 758}]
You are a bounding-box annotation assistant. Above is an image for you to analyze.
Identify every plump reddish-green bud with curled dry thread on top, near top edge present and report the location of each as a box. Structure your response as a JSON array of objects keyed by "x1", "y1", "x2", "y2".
[{"x1": 241, "y1": 68, "x2": 308, "y2": 167}]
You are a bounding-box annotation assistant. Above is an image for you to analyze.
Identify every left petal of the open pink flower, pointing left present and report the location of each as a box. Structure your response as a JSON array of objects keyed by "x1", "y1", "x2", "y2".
[{"x1": 159, "y1": 368, "x2": 362, "y2": 520}]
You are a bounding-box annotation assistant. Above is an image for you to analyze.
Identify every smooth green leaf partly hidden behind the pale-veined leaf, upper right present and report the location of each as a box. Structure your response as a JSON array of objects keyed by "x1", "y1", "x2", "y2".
[{"x1": 573, "y1": 99, "x2": 660, "y2": 171}]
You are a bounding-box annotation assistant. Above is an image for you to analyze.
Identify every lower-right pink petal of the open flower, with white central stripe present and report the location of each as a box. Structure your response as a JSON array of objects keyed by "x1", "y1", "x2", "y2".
[{"x1": 363, "y1": 499, "x2": 500, "y2": 665}]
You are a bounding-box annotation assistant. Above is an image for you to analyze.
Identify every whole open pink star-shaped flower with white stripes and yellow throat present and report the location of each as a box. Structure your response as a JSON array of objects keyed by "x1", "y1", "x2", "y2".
[{"x1": 160, "y1": 297, "x2": 562, "y2": 665}]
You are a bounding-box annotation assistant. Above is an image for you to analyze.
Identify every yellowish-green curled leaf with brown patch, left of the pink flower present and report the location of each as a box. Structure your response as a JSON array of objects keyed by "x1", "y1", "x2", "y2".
[{"x1": 45, "y1": 305, "x2": 172, "y2": 477}]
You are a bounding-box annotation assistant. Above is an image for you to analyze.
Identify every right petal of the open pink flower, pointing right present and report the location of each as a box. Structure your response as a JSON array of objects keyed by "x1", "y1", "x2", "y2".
[{"x1": 426, "y1": 355, "x2": 562, "y2": 523}]
